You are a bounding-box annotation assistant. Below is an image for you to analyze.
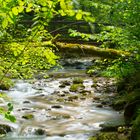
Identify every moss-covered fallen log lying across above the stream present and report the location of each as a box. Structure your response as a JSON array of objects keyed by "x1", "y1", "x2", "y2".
[{"x1": 56, "y1": 42, "x2": 130, "y2": 58}]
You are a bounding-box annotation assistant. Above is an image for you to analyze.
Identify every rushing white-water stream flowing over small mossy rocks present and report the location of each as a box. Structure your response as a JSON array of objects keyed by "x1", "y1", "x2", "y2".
[{"x1": 0, "y1": 58, "x2": 123, "y2": 140}]
